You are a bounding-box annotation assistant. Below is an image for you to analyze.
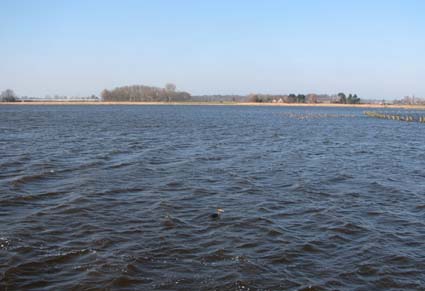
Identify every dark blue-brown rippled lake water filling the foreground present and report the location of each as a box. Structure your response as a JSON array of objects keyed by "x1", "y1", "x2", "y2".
[{"x1": 0, "y1": 106, "x2": 425, "y2": 290}]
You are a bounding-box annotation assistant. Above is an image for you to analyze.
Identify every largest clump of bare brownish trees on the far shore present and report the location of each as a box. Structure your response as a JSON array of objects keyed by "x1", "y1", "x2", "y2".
[{"x1": 101, "y1": 84, "x2": 191, "y2": 102}]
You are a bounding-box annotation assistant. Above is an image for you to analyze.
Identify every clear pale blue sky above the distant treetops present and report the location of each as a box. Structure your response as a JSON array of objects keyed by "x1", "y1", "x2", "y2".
[{"x1": 0, "y1": 0, "x2": 425, "y2": 99}]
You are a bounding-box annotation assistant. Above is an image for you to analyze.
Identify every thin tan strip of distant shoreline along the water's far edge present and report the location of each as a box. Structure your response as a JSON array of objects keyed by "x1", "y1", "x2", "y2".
[{"x1": 0, "y1": 101, "x2": 425, "y2": 110}]
